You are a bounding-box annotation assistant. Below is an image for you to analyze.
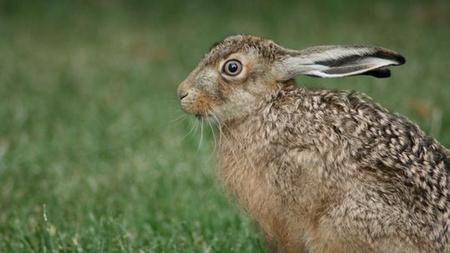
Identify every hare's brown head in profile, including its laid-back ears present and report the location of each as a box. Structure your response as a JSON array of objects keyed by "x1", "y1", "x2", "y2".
[{"x1": 178, "y1": 35, "x2": 405, "y2": 121}]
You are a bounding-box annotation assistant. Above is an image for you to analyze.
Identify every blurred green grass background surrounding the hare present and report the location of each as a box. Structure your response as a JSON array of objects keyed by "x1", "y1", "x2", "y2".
[{"x1": 0, "y1": 0, "x2": 450, "y2": 252}]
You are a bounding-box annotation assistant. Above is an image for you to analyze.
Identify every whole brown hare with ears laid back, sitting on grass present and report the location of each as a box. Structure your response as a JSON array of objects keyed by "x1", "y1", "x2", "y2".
[{"x1": 178, "y1": 35, "x2": 450, "y2": 253}]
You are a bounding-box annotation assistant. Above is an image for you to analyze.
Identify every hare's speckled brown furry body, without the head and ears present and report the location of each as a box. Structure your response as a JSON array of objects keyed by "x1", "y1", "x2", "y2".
[{"x1": 219, "y1": 83, "x2": 450, "y2": 252}]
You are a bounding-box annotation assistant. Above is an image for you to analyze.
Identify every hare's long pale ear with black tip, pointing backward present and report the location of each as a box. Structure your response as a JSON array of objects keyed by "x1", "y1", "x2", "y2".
[{"x1": 275, "y1": 46, "x2": 405, "y2": 80}]
